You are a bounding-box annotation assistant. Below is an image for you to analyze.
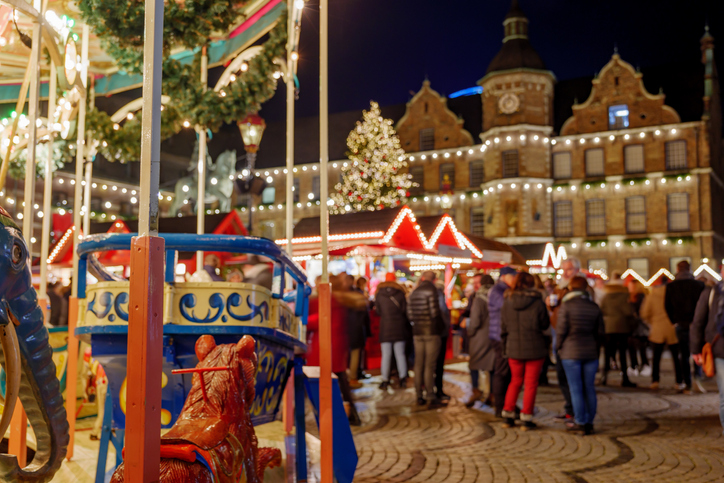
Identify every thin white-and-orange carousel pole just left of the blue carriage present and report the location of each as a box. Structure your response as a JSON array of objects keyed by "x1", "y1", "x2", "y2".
[{"x1": 65, "y1": 21, "x2": 90, "y2": 460}]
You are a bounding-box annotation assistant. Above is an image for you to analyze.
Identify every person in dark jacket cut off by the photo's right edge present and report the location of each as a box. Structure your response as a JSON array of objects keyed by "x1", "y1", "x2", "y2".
[{"x1": 689, "y1": 266, "x2": 724, "y2": 428}]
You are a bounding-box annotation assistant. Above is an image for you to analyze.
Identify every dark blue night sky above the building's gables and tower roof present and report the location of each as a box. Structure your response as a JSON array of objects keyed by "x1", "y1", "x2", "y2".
[{"x1": 260, "y1": 0, "x2": 724, "y2": 122}]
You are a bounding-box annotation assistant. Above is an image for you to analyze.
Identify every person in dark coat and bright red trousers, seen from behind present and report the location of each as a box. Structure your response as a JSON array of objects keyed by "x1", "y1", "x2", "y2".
[{"x1": 500, "y1": 272, "x2": 550, "y2": 431}]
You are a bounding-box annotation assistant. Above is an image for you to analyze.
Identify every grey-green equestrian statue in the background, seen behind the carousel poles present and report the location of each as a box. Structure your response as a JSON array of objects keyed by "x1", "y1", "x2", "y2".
[{"x1": 169, "y1": 142, "x2": 236, "y2": 216}]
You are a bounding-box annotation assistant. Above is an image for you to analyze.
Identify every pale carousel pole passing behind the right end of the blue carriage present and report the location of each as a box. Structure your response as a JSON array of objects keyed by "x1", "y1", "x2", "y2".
[{"x1": 283, "y1": 0, "x2": 295, "y2": 436}]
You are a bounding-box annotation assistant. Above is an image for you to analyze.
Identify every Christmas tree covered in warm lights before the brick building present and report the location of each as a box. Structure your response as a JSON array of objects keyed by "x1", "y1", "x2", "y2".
[{"x1": 329, "y1": 102, "x2": 413, "y2": 214}]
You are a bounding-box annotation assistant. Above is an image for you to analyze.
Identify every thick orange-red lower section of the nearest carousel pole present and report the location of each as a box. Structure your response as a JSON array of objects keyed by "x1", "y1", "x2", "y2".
[{"x1": 124, "y1": 236, "x2": 165, "y2": 483}]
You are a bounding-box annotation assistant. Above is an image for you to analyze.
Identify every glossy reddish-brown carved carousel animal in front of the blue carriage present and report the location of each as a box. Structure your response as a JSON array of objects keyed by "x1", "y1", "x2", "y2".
[{"x1": 111, "y1": 335, "x2": 281, "y2": 483}]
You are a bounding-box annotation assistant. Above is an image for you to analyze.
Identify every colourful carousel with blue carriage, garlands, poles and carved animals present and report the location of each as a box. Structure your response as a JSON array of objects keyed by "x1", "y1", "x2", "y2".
[{"x1": 0, "y1": 0, "x2": 356, "y2": 482}]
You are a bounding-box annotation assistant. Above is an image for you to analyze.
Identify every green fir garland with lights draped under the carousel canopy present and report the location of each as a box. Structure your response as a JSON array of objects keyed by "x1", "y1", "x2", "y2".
[{"x1": 80, "y1": 0, "x2": 287, "y2": 163}]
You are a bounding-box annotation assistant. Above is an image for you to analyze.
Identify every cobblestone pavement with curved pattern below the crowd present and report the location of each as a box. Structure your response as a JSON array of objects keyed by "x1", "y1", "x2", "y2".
[{"x1": 336, "y1": 361, "x2": 724, "y2": 483}]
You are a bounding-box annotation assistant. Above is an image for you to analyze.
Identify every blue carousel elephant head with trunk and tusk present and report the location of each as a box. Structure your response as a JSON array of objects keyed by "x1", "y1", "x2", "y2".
[{"x1": 0, "y1": 207, "x2": 69, "y2": 482}]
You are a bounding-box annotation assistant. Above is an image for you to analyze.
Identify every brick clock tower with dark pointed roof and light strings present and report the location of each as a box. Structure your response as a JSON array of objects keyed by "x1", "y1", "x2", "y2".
[{"x1": 478, "y1": 0, "x2": 555, "y2": 246}]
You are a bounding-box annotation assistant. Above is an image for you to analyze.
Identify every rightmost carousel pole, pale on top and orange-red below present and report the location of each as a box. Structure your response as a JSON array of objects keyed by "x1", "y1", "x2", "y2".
[{"x1": 319, "y1": 0, "x2": 334, "y2": 483}]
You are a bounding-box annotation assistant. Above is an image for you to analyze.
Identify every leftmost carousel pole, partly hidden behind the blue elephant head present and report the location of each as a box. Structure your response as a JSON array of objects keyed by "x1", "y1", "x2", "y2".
[{"x1": 8, "y1": 0, "x2": 42, "y2": 467}]
